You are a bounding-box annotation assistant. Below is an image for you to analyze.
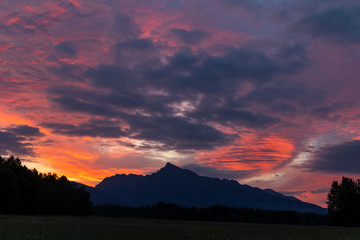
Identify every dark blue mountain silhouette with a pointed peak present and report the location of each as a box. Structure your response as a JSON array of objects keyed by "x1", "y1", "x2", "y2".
[{"x1": 91, "y1": 163, "x2": 326, "y2": 213}]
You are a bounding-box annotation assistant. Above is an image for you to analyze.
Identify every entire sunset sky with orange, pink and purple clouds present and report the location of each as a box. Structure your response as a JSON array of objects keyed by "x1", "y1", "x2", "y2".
[{"x1": 0, "y1": 0, "x2": 360, "y2": 206}]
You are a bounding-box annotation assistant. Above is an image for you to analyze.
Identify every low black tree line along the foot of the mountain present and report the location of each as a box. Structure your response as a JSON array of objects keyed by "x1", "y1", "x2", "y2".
[{"x1": 94, "y1": 202, "x2": 328, "y2": 225}]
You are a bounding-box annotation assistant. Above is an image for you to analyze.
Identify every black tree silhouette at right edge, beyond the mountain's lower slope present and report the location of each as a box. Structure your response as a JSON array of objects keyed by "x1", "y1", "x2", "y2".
[{"x1": 327, "y1": 177, "x2": 360, "y2": 226}]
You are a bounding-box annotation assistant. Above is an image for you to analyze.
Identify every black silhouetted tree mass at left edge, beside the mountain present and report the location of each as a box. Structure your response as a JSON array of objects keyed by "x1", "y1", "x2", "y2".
[{"x1": 0, "y1": 156, "x2": 92, "y2": 215}]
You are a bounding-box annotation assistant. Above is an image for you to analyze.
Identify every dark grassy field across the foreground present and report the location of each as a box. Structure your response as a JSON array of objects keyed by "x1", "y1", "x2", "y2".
[{"x1": 0, "y1": 216, "x2": 360, "y2": 240}]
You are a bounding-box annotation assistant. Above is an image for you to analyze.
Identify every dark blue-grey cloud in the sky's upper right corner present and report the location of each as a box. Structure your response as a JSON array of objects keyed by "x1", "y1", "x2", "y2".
[{"x1": 295, "y1": 4, "x2": 360, "y2": 44}]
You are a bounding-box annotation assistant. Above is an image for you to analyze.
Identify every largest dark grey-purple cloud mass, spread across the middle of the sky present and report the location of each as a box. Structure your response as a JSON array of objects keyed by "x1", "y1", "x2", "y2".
[{"x1": 44, "y1": 39, "x2": 312, "y2": 150}]
